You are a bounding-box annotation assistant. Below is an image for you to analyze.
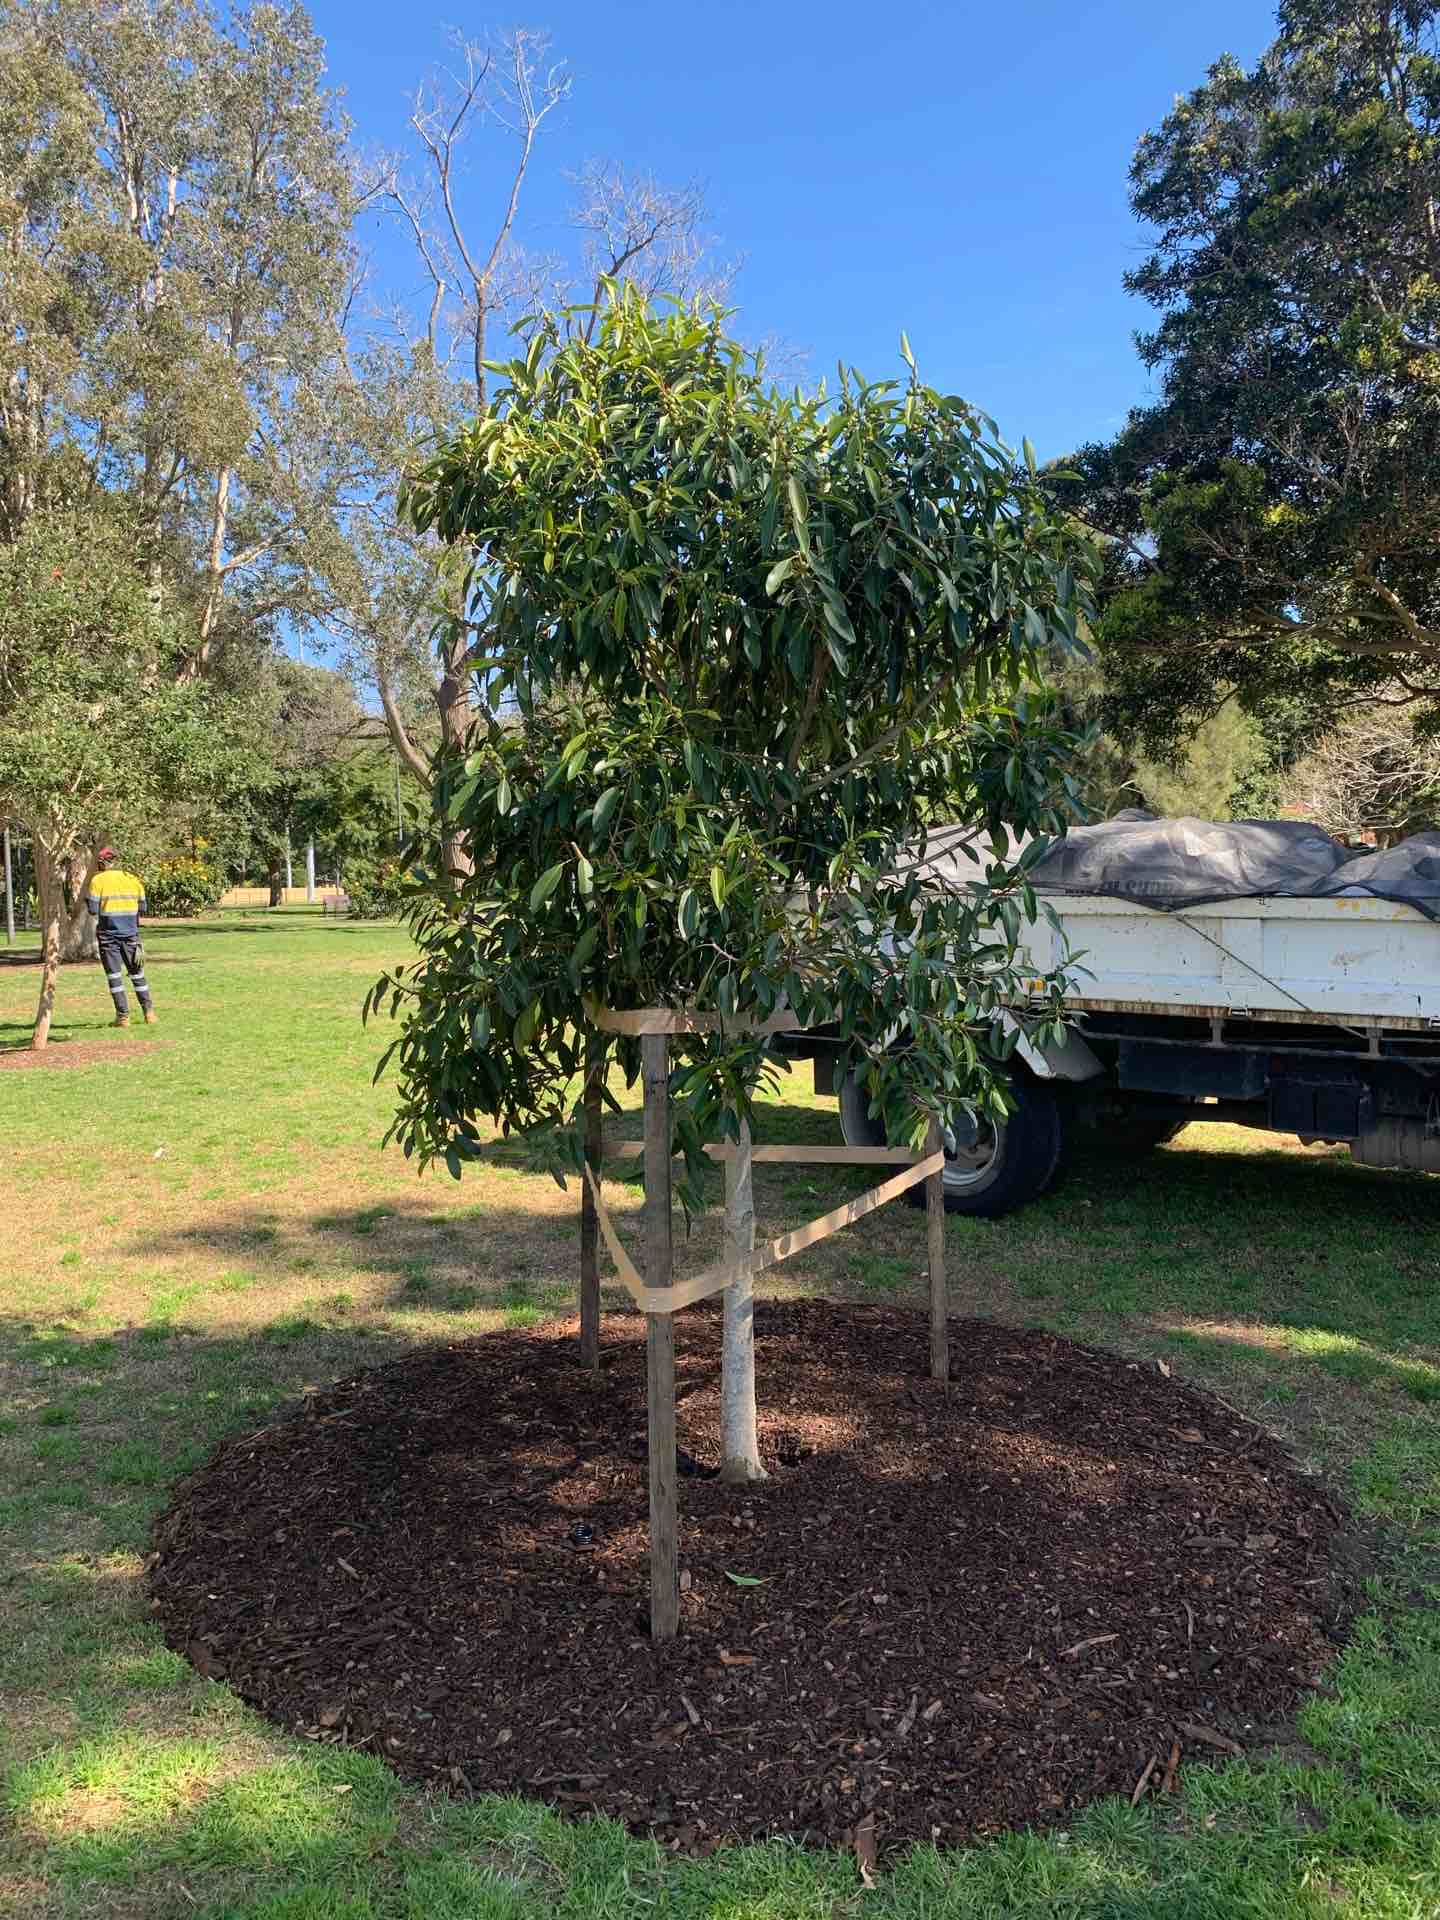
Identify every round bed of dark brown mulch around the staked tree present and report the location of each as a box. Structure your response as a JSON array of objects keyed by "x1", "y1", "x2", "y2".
[{"x1": 150, "y1": 1302, "x2": 1346, "y2": 1851}]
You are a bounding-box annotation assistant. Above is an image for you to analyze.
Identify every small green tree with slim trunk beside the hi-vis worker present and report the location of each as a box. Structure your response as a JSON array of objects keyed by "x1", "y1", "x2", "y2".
[{"x1": 0, "y1": 515, "x2": 238, "y2": 1048}]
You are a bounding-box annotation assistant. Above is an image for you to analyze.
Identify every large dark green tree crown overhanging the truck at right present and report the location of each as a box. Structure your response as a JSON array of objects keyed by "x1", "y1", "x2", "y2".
[{"x1": 1060, "y1": 0, "x2": 1440, "y2": 753}]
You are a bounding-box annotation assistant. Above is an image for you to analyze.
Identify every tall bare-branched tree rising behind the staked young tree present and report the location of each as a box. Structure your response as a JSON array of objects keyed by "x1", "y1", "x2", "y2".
[{"x1": 326, "y1": 31, "x2": 726, "y2": 821}]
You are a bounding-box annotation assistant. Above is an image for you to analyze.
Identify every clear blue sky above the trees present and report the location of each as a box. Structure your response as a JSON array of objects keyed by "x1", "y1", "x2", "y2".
[{"x1": 313, "y1": 0, "x2": 1273, "y2": 457}]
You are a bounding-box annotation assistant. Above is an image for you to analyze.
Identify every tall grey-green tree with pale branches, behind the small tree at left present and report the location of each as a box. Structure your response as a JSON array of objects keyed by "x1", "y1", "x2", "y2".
[{"x1": 0, "y1": 0, "x2": 355, "y2": 956}]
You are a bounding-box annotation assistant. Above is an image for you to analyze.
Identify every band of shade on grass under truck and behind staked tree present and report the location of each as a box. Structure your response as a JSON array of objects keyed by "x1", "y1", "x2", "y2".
[{"x1": 109, "y1": 1106, "x2": 1440, "y2": 1419}]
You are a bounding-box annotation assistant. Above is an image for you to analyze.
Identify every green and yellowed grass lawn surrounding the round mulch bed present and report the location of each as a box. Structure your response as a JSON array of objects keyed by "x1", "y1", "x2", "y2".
[{"x1": 0, "y1": 910, "x2": 1440, "y2": 1920}]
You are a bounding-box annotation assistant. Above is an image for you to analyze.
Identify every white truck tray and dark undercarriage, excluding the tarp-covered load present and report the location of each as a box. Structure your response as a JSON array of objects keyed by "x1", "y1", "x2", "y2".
[{"x1": 793, "y1": 893, "x2": 1440, "y2": 1215}]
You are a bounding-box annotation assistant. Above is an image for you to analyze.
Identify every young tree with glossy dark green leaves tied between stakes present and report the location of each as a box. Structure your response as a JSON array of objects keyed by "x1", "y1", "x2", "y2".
[{"x1": 371, "y1": 290, "x2": 1085, "y2": 1471}]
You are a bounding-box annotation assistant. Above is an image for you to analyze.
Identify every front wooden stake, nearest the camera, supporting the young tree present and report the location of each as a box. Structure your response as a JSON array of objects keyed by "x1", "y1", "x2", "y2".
[{"x1": 639, "y1": 1033, "x2": 680, "y2": 1640}]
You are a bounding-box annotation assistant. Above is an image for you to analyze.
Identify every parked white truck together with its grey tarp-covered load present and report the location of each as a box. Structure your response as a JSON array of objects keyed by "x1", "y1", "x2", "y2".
[{"x1": 789, "y1": 814, "x2": 1440, "y2": 1215}]
